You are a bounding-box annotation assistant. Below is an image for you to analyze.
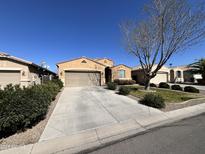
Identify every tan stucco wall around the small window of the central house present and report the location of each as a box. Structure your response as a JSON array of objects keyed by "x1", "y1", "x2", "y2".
[{"x1": 112, "y1": 65, "x2": 132, "y2": 80}]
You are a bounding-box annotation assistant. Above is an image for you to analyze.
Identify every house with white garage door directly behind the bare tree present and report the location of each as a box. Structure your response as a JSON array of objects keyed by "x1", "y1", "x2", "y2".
[{"x1": 132, "y1": 65, "x2": 169, "y2": 84}]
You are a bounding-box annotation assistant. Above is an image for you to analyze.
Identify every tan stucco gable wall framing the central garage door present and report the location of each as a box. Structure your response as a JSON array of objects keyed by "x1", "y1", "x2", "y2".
[{"x1": 57, "y1": 58, "x2": 106, "y2": 85}]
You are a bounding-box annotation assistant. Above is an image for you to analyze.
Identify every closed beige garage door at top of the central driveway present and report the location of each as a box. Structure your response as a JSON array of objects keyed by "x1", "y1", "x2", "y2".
[{"x1": 65, "y1": 71, "x2": 100, "y2": 87}]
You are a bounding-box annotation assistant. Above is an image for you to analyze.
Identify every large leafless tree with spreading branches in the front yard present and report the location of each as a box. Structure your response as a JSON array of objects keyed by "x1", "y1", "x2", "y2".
[{"x1": 121, "y1": 0, "x2": 205, "y2": 90}]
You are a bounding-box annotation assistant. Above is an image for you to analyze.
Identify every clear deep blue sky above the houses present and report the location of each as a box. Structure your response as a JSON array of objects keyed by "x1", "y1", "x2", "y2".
[{"x1": 0, "y1": 0, "x2": 205, "y2": 71}]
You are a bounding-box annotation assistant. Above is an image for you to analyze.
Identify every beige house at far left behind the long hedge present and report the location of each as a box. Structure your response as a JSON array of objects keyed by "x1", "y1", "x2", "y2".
[{"x1": 0, "y1": 53, "x2": 56, "y2": 88}]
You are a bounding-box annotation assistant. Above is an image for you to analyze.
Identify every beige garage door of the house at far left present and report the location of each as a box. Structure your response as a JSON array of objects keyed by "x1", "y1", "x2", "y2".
[{"x1": 0, "y1": 71, "x2": 20, "y2": 87}]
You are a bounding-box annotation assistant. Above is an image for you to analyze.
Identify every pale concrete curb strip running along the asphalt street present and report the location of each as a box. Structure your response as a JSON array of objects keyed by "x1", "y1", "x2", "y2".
[{"x1": 0, "y1": 103, "x2": 205, "y2": 154}]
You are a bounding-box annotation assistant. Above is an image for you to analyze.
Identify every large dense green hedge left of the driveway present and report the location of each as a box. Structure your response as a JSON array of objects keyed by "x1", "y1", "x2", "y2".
[{"x1": 0, "y1": 81, "x2": 61, "y2": 138}]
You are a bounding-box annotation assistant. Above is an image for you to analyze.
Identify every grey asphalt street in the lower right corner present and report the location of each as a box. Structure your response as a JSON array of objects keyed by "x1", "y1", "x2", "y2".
[{"x1": 90, "y1": 114, "x2": 205, "y2": 154}]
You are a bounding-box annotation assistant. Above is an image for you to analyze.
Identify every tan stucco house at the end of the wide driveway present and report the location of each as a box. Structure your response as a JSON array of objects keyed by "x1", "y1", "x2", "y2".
[{"x1": 57, "y1": 57, "x2": 131, "y2": 87}]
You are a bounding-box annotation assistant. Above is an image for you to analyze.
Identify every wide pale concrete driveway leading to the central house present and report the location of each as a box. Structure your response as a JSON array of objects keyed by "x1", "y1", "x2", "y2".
[{"x1": 40, "y1": 87, "x2": 162, "y2": 141}]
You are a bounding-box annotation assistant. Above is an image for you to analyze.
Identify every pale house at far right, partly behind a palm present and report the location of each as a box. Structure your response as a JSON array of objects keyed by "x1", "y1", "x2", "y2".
[{"x1": 170, "y1": 66, "x2": 202, "y2": 83}]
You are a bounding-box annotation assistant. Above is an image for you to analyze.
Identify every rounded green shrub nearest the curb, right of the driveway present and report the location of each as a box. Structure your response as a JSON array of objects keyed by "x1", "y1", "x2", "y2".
[{"x1": 140, "y1": 93, "x2": 165, "y2": 109}]
